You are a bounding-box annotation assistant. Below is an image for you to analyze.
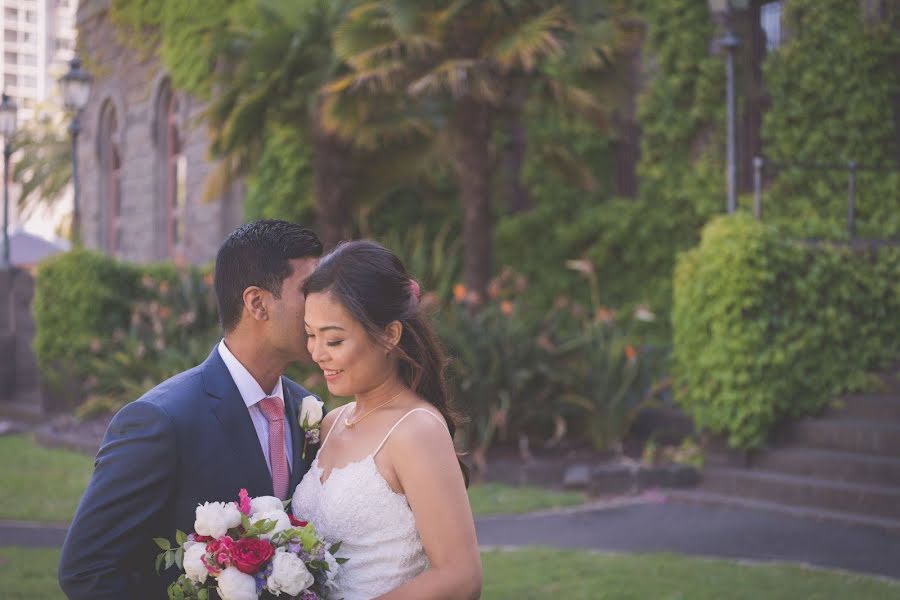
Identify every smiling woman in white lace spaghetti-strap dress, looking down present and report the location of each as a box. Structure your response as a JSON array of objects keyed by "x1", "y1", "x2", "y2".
[{"x1": 292, "y1": 241, "x2": 481, "y2": 600}]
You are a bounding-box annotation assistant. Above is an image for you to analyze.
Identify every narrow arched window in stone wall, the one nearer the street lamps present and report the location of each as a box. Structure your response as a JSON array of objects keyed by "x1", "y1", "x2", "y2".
[{"x1": 98, "y1": 102, "x2": 122, "y2": 254}]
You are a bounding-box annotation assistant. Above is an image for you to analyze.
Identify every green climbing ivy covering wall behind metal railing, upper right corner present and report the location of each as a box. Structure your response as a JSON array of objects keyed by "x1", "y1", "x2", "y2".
[{"x1": 762, "y1": 0, "x2": 900, "y2": 239}]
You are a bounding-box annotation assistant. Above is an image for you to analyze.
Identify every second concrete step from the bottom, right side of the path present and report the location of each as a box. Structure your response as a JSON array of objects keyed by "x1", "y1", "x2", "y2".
[{"x1": 701, "y1": 468, "x2": 900, "y2": 519}]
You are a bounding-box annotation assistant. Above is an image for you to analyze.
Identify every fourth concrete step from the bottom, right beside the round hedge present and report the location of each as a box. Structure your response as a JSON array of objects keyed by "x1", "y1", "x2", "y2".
[{"x1": 777, "y1": 418, "x2": 900, "y2": 456}]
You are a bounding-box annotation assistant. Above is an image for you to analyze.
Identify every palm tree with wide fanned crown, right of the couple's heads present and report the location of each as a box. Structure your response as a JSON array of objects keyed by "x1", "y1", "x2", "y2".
[{"x1": 326, "y1": 0, "x2": 628, "y2": 295}]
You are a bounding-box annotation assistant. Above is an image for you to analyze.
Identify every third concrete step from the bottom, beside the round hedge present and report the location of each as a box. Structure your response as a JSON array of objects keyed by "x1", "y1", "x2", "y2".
[{"x1": 751, "y1": 447, "x2": 900, "y2": 486}]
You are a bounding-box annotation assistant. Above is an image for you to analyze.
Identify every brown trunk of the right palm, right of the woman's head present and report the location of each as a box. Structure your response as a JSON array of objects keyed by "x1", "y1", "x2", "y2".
[{"x1": 453, "y1": 98, "x2": 494, "y2": 299}]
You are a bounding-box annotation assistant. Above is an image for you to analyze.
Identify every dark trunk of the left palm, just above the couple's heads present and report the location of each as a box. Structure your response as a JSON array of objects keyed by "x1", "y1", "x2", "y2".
[{"x1": 313, "y1": 129, "x2": 354, "y2": 250}]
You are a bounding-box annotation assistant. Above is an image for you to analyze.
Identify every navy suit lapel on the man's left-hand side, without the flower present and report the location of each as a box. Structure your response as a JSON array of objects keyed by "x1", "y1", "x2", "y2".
[{"x1": 203, "y1": 347, "x2": 273, "y2": 496}]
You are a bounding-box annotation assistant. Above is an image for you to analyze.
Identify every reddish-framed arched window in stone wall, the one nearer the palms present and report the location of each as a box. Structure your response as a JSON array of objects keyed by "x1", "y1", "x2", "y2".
[{"x1": 156, "y1": 81, "x2": 187, "y2": 258}]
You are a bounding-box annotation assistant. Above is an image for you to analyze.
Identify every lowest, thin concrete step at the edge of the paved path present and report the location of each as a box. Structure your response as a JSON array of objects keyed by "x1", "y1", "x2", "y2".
[{"x1": 665, "y1": 490, "x2": 900, "y2": 535}]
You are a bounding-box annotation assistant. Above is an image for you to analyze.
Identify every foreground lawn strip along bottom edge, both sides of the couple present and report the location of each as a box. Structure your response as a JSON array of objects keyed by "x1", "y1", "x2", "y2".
[{"x1": 0, "y1": 548, "x2": 900, "y2": 600}]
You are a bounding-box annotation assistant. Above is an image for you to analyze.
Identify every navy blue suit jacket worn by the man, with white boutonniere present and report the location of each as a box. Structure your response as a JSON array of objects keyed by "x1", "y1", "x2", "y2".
[{"x1": 59, "y1": 348, "x2": 318, "y2": 600}]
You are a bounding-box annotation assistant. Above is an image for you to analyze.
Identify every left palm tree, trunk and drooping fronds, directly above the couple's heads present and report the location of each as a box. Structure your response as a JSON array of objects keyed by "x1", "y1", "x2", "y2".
[{"x1": 200, "y1": 0, "x2": 436, "y2": 247}]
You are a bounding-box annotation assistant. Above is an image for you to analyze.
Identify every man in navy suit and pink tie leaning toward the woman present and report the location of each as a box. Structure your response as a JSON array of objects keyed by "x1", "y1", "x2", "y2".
[{"x1": 59, "y1": 221, "x2": 322, "y2": 600}]
